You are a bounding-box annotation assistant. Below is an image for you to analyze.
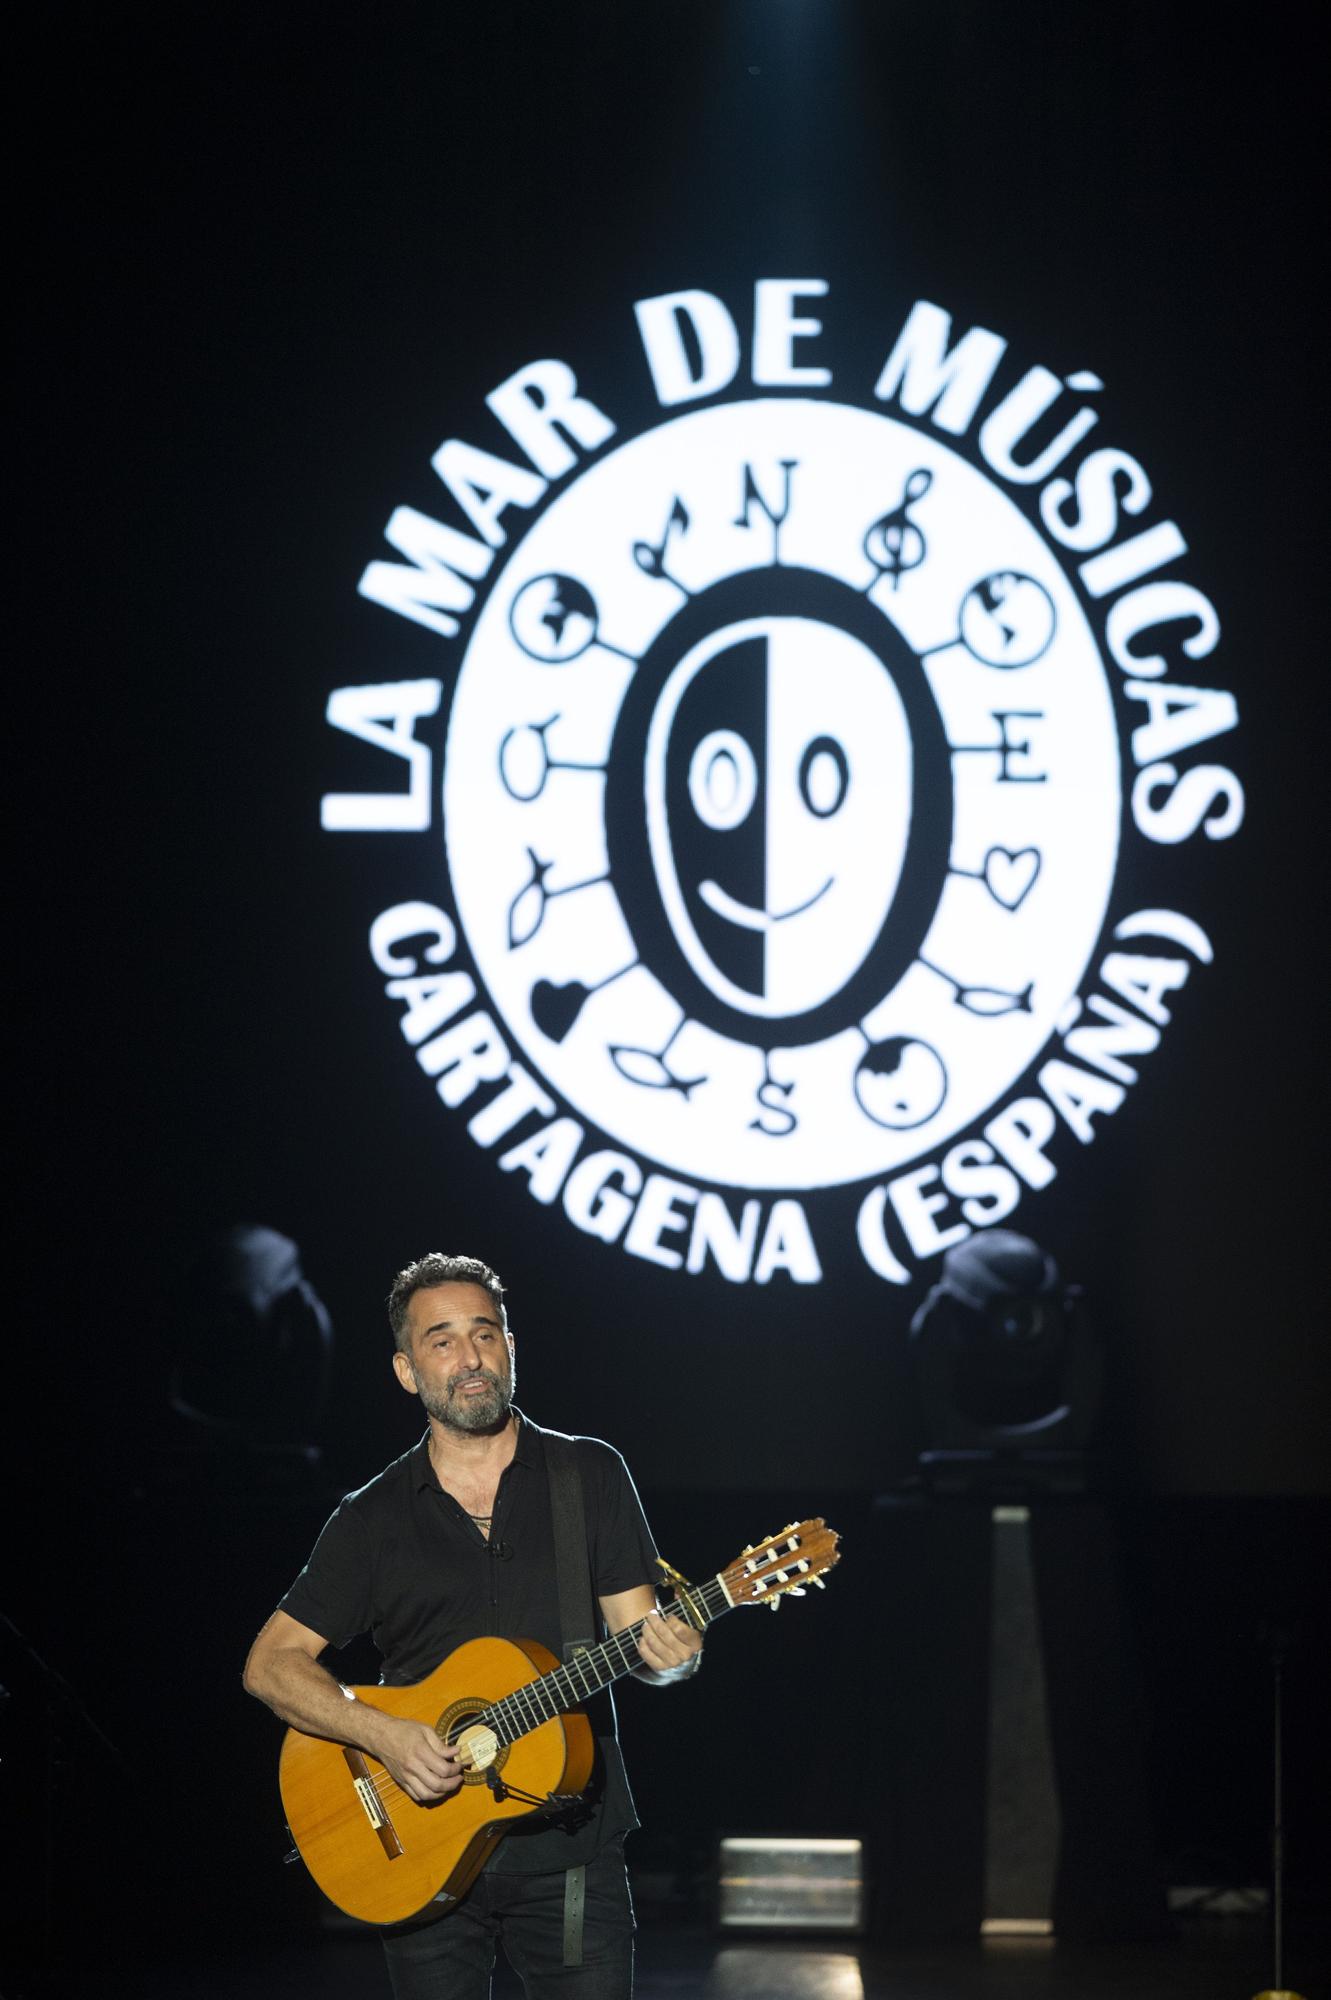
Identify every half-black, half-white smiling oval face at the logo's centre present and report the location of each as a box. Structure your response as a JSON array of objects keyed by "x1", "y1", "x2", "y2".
[{"x1": 644, "y1": 616, "x2": 911, "y2": 1018}]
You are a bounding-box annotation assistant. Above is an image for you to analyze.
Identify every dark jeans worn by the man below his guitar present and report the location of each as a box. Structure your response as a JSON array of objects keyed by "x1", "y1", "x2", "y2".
[{"x1": 384, "y1": 1840, "x2": 634, "y2": 2000}]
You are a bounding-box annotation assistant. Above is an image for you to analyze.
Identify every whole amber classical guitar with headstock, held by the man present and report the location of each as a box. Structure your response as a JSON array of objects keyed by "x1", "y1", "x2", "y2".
[{"x1": 280, "y1": 1520, "x2": 837, "y2": 1924}]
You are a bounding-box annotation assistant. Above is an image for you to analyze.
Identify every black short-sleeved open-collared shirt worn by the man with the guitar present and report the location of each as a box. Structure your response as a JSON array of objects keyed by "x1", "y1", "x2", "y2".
[{"x1": 280, "y1": 1418, "x2": 656, "y2": 1874}]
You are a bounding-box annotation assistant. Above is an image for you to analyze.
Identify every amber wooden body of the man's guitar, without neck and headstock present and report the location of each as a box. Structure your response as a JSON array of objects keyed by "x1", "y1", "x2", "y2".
[{"x1": 278, "y1": 1638, "x2": 596, "y2": 1924}]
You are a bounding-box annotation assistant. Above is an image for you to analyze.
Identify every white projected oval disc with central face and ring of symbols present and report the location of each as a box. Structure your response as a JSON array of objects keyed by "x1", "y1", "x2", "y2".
[{"x1": 444, "y1": 398, "x2": 1121, "y2": 1190}]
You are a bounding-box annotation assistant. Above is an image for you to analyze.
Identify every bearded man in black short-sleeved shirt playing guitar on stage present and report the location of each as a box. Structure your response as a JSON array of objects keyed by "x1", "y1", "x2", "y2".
[{"x1": 244, "y1": 1254, "x2": 701, "y2": 2000}]
